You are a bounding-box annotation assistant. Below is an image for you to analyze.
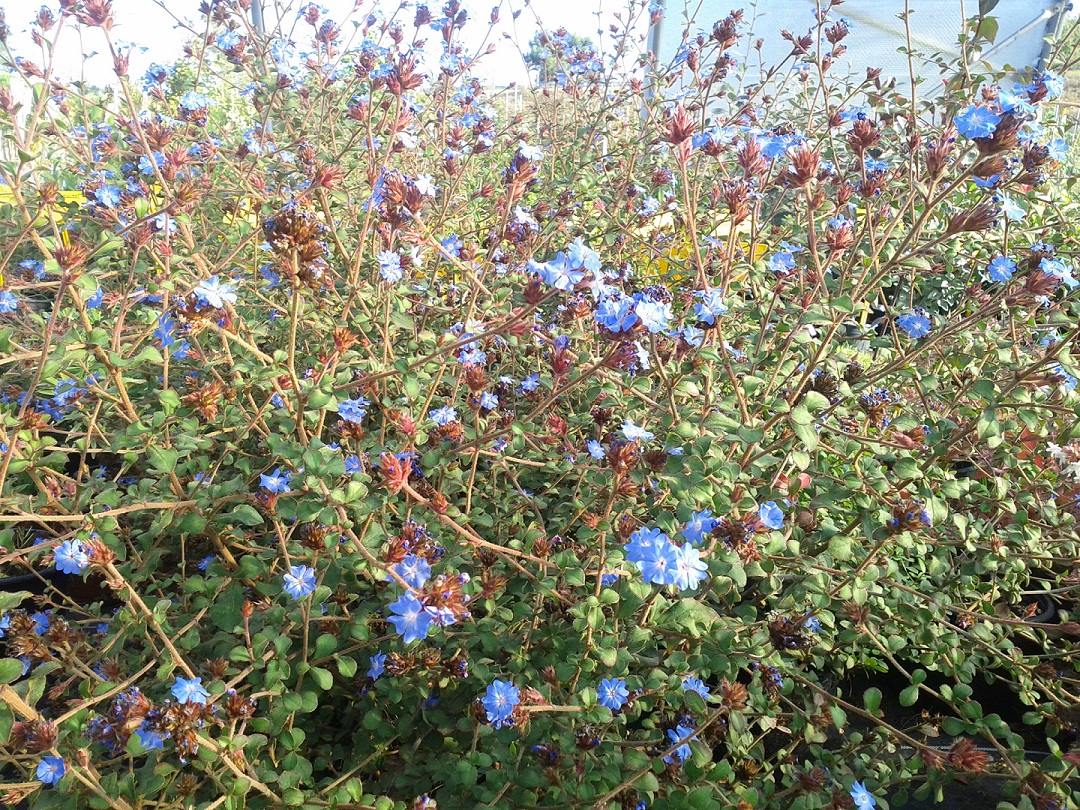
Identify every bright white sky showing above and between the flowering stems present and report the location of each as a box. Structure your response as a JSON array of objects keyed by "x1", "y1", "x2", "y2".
[{"x1": 6, "y1": 0, "x2": 644, "y2": 86}]
